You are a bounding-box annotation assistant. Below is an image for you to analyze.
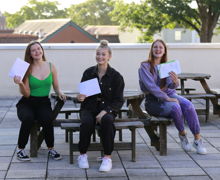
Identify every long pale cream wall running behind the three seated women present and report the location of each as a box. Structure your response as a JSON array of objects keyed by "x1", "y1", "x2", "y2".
[{"x1": 0, "y1": 43, "x2": 220, "y2": 96}]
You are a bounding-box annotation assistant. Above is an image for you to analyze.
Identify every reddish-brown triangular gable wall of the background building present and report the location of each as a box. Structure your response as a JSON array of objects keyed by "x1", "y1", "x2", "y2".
[{"x1": 47, "y1": 26, "x2": 95, "y2": 43}]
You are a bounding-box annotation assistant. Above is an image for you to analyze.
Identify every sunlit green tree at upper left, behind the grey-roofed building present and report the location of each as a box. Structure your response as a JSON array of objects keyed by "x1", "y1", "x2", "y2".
[{"x1": 4, "y1": 0, "x2": 66, "y2": 28}]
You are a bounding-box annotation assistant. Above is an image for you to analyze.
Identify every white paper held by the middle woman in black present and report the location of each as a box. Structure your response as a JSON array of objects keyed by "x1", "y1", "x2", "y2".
[{"x1": 79, "y1": 78, "x2": 101, "y2": 96}]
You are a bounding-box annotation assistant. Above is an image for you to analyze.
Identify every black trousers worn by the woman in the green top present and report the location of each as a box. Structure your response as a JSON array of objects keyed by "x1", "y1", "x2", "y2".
[{"x1": 16, "y1": 97, "x2": 54, "y2": 149}]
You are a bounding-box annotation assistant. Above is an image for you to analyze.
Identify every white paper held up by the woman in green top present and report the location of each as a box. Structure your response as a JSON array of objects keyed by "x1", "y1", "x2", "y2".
[{"x1": 9, "y1": 58, "x2": 30, "y2": 79}]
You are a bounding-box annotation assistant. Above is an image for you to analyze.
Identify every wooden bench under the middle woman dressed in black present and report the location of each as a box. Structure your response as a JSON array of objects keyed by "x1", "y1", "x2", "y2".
[{"x1": 61, "y1": 121, "x2": 144, "y2": 164}]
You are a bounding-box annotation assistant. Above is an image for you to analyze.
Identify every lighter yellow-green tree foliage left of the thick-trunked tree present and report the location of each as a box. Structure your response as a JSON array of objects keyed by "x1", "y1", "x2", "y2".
[{"x1": 111, "y1": 0, "x2": 174, "y2": 42}]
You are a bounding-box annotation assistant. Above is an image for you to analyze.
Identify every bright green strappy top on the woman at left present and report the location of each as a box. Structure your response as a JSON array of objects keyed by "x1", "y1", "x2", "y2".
[{"x1": 29, "y1": 63, "x2": 53, "y2": 97}]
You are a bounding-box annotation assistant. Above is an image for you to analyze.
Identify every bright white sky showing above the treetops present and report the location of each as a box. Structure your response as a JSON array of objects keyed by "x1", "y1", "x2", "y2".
[{"x1": 0, "y1": 0, "x2": 140, "y2": 13}]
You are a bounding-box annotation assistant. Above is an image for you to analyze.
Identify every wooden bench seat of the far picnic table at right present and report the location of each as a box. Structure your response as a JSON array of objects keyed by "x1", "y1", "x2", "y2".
[{"x1": 181, "y1": 93, "x2": 216, "y2": 122}]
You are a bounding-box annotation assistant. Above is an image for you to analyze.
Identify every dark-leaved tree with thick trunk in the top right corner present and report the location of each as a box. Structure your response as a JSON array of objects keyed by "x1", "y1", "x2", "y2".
[{"x1": 152, "y1": 0, "x2": 220, "y2": 42}]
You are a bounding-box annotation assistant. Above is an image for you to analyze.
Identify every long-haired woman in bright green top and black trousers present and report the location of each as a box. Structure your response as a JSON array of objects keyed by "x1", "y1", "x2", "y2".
[{"x1": 14, "y1": 41, "x2": 65, "y2": 161}]
